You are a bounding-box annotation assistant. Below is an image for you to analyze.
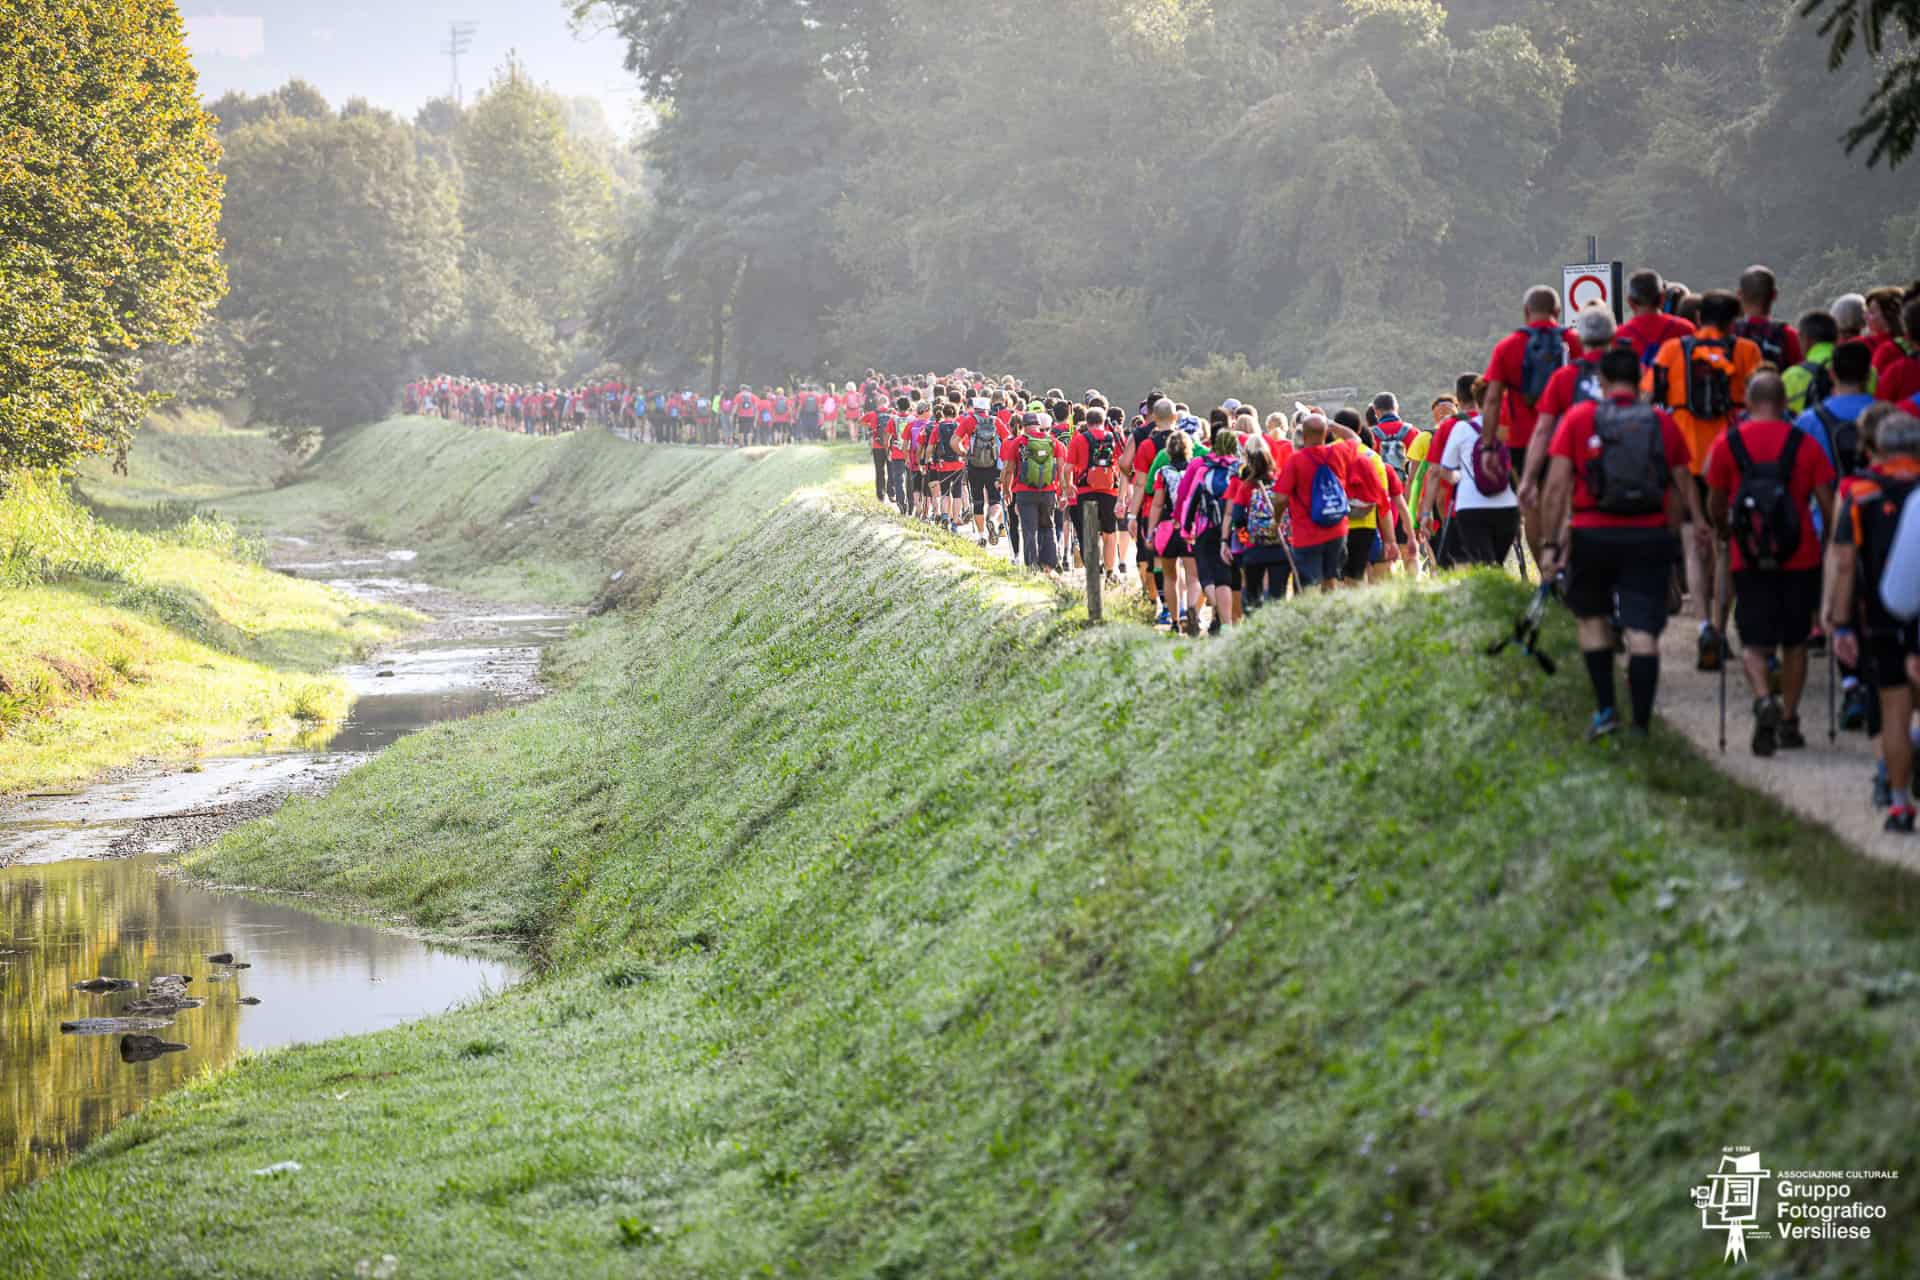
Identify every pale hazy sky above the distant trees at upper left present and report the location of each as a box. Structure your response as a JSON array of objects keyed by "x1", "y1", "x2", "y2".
[{"x1": 180, "y1": 0, "x2": 639, "y2": 134}]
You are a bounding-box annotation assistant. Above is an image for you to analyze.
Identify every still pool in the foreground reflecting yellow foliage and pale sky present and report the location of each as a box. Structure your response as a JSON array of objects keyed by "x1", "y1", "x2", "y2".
[{"x1": 0, "y1": 858, "x2": 515, "y2": 1188}]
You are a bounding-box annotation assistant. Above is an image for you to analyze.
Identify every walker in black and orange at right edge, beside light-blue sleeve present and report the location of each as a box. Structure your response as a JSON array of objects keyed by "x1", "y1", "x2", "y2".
[{"x1": 1824, "y1": 413, "x2": 1920, "y2": 835}]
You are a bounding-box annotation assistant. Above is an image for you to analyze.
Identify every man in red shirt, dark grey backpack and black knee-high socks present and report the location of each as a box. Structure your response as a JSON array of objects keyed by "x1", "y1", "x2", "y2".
[{"x1": 1540, "y1": 347, "x2": 1705, "y2": 741}]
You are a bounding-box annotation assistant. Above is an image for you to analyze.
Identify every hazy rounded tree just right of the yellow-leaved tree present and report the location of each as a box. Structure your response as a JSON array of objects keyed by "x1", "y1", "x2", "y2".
[{"x1": 223, "y1": 115, "x2": 461, "y2": 428}]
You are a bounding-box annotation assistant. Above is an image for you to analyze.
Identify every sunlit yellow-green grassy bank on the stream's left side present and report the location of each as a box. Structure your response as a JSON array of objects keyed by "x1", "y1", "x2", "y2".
[{"x1": 0, "y1": 420, "x2": 413, "y2": 794}]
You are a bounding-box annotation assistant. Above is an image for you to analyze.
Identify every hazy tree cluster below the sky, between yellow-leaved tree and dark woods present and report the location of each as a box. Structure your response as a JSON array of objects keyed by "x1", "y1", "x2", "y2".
[{"x1": 189, "y1": 78, "x2": 634, "y2": 434}]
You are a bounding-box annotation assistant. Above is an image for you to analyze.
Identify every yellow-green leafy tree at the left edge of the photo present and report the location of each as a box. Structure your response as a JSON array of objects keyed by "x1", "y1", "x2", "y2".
[{"x1": 0, "y1": 0, "x2": 227, "y2": 472}]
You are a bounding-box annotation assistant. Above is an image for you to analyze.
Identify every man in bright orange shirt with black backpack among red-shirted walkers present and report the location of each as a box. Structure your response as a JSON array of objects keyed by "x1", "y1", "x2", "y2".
[{"x1": 1642, "y1": 290, "x2": 1761, "y2": 672}]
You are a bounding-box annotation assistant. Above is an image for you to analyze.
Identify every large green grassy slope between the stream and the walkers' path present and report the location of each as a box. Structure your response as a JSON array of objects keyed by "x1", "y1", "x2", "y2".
[{"x1": 0, "y1": 418, "x2": 1920, "y2": 1280}]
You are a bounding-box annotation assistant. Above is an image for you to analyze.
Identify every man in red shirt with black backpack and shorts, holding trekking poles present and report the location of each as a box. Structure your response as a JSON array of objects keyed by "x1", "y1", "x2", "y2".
[{"x1": 1705, "y1": 372, "x2": 1836, "y2": 758}]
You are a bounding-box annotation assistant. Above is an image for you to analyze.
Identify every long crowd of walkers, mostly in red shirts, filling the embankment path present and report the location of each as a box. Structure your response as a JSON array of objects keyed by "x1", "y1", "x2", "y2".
[{"x1": 407, "y1": 267, "x2": 1920, "y2": 833}]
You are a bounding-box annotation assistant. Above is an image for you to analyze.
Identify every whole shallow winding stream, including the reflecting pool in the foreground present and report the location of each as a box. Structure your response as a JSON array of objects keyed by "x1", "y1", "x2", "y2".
[{"x1": 0, "y1": 557, "x2": 572, "y2": 1190}]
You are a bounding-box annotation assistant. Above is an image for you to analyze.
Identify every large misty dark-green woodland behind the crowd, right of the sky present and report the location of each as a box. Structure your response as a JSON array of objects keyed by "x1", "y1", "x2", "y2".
[{"x1": 576, "y1": 0, "x2": 1920, "y2": 397}]
